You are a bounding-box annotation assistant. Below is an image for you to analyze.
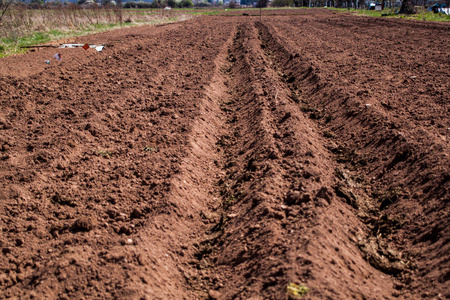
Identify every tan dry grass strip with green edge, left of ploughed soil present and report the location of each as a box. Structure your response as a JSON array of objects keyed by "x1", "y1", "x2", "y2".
[{"x1": 0, "y1": 5, "x2": 194, "y2": 57}]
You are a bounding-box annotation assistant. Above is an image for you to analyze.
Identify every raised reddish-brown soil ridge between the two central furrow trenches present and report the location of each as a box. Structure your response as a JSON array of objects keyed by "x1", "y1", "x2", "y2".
[{"x1": 202, "y1": 23, "x2": 392, "y2": 299}]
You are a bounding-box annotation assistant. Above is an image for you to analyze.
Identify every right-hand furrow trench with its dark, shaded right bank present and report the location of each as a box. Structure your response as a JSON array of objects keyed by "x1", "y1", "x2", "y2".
[{"x1": 258, "y1": 19, "x2": 449, "y2": 298}]
